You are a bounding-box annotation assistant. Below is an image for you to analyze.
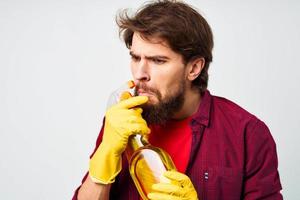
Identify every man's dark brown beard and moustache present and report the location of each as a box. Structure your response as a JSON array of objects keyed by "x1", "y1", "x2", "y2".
[{"x1": 134, "y1": 80, "x2": 185, "y2": 125}]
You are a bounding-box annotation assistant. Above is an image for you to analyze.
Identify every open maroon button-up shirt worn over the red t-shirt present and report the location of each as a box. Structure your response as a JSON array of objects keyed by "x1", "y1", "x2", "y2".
[{"x1": 73, "y1": 91, "x2": 282, "y2": 200}]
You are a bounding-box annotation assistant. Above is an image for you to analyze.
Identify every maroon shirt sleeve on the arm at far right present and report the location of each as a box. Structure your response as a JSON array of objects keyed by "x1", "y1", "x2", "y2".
[{"x1": 243, "y1": 120, "x2": 283, "y2": 200}]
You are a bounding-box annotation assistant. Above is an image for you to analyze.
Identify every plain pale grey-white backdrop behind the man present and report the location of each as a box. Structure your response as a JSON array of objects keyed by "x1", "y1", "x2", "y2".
[{"x1": 0, "y1": 0, "x2": 300, "y2": 200}]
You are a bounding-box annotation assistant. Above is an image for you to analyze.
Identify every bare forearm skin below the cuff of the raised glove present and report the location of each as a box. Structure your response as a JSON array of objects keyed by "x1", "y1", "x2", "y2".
[{"x1": 77, "y1": 176, "x2": 111, "y2": 200}]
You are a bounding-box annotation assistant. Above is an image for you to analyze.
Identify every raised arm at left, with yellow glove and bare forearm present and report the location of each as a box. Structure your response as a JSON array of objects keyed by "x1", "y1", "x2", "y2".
[{"x1": 73, "y1": 96, "x2": 150, "y2": 200}]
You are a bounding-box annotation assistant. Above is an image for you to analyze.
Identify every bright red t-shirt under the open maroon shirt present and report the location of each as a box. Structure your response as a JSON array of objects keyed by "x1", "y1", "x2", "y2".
[{"x1": 149, "y1": 117, "x2": 192, "y2": 173}]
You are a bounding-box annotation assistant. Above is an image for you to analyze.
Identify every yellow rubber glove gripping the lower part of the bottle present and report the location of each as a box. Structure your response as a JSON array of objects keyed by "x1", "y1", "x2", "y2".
[{"x1": 148, "y1": 171, "x2": 198, "y2": 200}]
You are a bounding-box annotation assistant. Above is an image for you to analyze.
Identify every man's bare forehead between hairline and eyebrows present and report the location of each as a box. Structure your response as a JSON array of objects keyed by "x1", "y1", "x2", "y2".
[{"x1": 130, "y1": 32, "x2": 181, "y2": 58}]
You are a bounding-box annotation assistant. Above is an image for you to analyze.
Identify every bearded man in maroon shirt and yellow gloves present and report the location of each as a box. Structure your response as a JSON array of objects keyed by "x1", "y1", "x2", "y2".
[{"x1": 73, "y1": 1, "x2": 282, "y2": 200}]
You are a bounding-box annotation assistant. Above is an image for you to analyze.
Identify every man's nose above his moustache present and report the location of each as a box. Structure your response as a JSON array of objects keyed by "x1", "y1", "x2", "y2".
[{"x1": 132, "y1": 59, "x2": 150, "y2": 83}]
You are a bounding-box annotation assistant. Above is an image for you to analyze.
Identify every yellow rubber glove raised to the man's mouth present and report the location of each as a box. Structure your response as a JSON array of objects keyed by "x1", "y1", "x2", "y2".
[{"x1": 89, "y1": 96, "x2": 150, "y2": 184}]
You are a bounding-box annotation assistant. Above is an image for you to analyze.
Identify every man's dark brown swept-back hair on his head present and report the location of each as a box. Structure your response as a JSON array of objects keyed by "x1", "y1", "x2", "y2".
[{"x1": 116, "y1": 0, "x2": 214, "y2": 93}]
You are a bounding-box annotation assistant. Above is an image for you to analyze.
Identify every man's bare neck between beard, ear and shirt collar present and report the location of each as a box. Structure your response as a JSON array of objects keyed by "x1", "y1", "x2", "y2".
[{"x1": 172, "y1": 86, "x2": 201, "y2": 120}]
